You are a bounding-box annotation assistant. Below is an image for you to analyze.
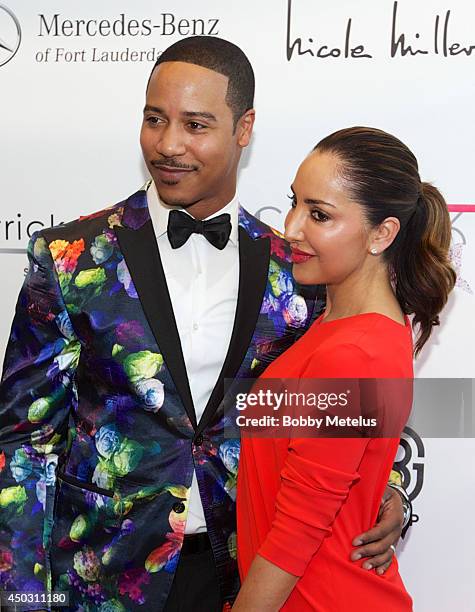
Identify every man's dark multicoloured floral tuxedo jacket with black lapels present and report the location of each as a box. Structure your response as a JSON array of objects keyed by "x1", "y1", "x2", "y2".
[{"x1": 0, "y1": 188, "x2": 322, "y2": 612}]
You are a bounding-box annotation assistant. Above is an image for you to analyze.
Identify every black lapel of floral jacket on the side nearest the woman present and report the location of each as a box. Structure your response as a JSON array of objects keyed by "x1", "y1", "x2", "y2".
[{"x1": 197, "y1": 226, "x2": 270, "y2": 433}]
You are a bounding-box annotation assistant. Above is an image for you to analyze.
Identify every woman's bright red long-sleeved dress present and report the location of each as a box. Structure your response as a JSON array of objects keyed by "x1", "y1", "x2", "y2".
[{"x1": 237, "y1": 313, "x2": 413, "y2": 612}]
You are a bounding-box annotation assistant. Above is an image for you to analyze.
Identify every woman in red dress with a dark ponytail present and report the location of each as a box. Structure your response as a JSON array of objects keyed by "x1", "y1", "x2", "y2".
[{"x1": 233, "y1": 127, "x2": 455, "y2": 612}]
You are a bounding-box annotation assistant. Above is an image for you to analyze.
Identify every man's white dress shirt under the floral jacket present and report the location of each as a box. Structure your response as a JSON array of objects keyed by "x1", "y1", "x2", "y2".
[{"x1": 147, "y1": 181, "x2": 239, "y2": 534}]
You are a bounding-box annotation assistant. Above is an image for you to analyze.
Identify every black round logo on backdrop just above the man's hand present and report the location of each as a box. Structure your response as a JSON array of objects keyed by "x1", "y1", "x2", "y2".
[{"x1": 394, "y1": 427, "x2": 425, "y2": 523}]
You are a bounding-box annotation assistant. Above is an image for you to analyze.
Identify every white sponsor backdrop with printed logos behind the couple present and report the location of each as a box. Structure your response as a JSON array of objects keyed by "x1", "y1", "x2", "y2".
[{"x1": 0, "y1": 0, "x2": 475, "y2": 612}]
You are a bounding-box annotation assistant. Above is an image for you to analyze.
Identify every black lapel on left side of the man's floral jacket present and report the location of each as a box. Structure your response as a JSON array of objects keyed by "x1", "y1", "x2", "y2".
[{"x1": 115, "y1": 220, "x2": 196, "y2": 429}]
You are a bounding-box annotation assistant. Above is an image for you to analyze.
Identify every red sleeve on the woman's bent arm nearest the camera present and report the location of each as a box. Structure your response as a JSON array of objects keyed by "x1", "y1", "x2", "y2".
[{"x1": 258, "y1": 344, "x2": 378, "y2": 576}]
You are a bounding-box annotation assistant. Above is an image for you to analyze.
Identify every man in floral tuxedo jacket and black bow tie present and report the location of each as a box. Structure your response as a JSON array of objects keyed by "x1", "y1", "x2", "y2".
[{"x1": 0, "y1": 37, "x2": 410, "y2": 612}]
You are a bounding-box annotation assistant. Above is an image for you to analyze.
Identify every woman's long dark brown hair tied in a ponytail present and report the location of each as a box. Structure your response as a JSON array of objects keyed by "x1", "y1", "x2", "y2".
[{"x1": 314, "y1": 127, "x2": 456, "y2": 357}]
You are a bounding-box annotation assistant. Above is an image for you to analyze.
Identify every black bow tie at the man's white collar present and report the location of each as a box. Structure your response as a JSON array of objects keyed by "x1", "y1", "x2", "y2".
[{"x1": 167, "y1": 210, "x2": 231, "y2": 251}]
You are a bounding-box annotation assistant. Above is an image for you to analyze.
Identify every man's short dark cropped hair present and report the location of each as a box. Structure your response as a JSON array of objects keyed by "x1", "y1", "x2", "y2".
[{"x1": 152, "y1": 36, "x2": 255, "y2": 127}]
